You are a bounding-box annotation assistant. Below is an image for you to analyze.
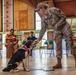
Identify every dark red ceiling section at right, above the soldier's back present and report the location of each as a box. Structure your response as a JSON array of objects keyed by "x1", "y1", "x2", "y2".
[{"x1": 54, "y1": 0, "x2": 76, "y2": 17}]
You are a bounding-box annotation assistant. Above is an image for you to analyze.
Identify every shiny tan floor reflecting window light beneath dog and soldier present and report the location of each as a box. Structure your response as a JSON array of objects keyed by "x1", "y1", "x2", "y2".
[{"x1": 0, "y1": 50, "x2": 76, "y2": 75}]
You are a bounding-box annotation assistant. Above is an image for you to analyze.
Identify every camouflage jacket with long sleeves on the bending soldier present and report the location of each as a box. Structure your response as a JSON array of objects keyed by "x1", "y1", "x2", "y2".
[{"x1": 39, "y1": 7, "x2": 66, "y2": 40}]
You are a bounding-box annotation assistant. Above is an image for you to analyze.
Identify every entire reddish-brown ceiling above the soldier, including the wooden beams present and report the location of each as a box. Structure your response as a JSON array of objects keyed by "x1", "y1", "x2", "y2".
[{"x1": 21, "y1": 0, "x2": 76, "y2": 17}]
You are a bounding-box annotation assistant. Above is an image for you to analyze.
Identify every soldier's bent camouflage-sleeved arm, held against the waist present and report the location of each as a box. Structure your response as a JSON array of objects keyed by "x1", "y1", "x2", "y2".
[{"x1": 54, "y1": 8, "x2": 66, "y2": 28}]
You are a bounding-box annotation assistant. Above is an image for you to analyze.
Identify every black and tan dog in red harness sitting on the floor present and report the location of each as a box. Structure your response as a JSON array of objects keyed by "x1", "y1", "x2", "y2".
[{"x1": 2, "y1": 40, "x2": 33, "y2": 72}]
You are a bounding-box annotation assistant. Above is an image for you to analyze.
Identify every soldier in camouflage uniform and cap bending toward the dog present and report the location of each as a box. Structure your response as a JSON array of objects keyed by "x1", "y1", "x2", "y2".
[{"x1": 35, "y1": 3, "x2": 76, "y2": 69}]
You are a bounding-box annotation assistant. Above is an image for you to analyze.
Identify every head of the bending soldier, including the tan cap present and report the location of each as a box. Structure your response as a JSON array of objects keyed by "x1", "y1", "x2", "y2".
[{"x1": 35, "y1": 3, "x2": 48, "y2": 17}]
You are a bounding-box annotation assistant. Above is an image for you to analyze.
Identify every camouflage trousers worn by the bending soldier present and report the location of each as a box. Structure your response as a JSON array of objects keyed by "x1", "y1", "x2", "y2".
[{"x1": 54, "y1": 23, "x2": 76, "y2": 58}]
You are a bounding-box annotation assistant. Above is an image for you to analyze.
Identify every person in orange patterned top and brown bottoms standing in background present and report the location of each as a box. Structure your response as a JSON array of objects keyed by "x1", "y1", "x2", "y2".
[{"x1": 5, "y1": 29, "x2": 19, "y2": 58}]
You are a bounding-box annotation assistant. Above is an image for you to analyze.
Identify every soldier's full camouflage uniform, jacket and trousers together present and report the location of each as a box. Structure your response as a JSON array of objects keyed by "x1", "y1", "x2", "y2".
[{"x1": 39, "y1": 7, "x2": 73, "y2": 58}]
